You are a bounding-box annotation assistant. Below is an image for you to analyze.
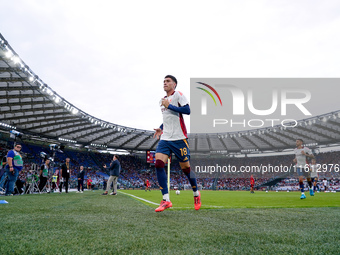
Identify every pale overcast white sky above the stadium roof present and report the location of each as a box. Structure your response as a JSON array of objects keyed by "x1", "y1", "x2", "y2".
[{"x1": 0, "y1": 0, "x2": 340, "y2": 130}]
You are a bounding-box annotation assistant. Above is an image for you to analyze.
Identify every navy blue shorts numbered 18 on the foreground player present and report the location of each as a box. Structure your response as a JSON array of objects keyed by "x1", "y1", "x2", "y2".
[{"x1": 156, "y1": 139, "x2": 190, "y2": 162}]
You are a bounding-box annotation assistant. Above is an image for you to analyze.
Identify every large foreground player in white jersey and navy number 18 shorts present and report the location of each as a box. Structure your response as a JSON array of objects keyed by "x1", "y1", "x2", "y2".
[{"x1": 154, "y1": 75, "x2": 201, "y2": 212}]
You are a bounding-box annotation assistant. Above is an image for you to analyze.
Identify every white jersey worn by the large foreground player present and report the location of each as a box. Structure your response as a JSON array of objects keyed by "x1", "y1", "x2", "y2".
[{"x1": 159, "y1": 91, "x2": 189, "y2": 141}]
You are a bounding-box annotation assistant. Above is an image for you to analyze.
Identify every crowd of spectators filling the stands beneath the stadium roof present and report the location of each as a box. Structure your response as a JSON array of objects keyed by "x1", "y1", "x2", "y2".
[{"x1": 0, "y1": 141, "x2": 340, "y2": 193}]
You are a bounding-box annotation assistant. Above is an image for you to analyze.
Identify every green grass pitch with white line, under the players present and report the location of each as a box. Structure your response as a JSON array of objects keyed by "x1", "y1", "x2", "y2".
[{"x1": 0, "y1": 190, "x2": 340, "y2": 254}]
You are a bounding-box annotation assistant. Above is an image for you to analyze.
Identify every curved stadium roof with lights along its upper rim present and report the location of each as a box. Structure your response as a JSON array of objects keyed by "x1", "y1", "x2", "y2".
[{"x1": 0, "y1": 34, "x2": 340, "y2": 154}]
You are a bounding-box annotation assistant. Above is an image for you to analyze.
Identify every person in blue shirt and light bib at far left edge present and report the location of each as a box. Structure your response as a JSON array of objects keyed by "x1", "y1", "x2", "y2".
[{"x1": 5, "y1": 143, "x2": 24, "y2": 196}]
